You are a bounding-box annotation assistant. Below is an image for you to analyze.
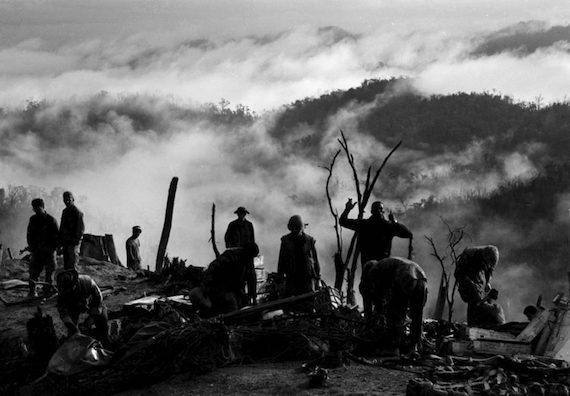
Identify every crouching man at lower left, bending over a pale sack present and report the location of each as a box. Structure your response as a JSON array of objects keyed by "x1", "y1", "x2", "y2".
[{"x1": 56, "y1": 269, "x2": 109, "y2": 346}]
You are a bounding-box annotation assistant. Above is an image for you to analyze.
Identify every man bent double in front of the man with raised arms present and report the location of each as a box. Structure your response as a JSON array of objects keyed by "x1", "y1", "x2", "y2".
[{"x1": 360, "y1": 257, "x2": 427, "y2": 355}]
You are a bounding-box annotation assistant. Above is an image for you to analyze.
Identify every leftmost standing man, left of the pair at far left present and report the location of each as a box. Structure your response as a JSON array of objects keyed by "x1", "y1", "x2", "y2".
[{"x1": 27, "y1": 198, "x2": 58, "y2": 297}]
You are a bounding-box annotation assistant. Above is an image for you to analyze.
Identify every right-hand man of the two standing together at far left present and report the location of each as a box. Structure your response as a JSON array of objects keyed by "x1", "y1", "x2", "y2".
[{"x1": 59, "y1": 191, "x2": 85, "y2": 269}]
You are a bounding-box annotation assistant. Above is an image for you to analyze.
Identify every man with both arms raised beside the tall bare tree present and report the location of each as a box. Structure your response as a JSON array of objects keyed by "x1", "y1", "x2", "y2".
[{"x1": 339, "y1": 199, "x2": 413, "y2": 265}]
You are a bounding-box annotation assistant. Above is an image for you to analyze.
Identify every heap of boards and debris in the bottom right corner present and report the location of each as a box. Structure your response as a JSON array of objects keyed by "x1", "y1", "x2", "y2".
[{"x1": 407, "y1": 294, "x2": 570, "y2": 396}]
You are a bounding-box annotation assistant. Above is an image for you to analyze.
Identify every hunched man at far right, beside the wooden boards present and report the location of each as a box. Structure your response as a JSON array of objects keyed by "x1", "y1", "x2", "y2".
[{"x1": 454, "y1": 245, "x2": 505, "y2": 327}]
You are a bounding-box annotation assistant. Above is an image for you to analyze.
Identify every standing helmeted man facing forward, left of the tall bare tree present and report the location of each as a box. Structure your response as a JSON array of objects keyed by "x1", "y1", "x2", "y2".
[{"x1": 277, "y1": 215, "x2": 321, "y2": 296}]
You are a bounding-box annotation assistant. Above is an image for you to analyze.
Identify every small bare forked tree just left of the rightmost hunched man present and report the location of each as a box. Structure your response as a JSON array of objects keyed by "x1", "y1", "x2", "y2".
[{"x1": 424, "y1": 217, "x2": 465, "y2": 322}]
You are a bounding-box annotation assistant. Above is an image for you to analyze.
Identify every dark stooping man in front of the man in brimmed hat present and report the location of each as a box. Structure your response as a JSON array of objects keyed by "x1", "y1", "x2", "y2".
[{"x1": 189, "y1": 242, "x2": 259, "y2": 317}]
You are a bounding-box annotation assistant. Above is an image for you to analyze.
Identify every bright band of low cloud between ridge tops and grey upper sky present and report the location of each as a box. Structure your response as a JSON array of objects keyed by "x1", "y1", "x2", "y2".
[{"x1": 0, "y1": 25, "x2": 570, "y2": 112}]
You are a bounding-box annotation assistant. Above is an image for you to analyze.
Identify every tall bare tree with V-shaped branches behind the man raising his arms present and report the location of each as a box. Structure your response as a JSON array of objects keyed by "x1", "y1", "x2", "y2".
[{"x1": 332, "y1": 129, "x2": 402, "y2": 304}]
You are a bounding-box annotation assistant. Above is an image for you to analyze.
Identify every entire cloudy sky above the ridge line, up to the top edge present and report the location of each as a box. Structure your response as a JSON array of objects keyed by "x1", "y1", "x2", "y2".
[{"x1": 0, "y1": 0, "x2": 570, "y2": 111}]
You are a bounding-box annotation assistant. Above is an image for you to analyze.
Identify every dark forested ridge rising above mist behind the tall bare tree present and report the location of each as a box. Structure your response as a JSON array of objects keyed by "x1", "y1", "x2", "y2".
[{"x1": 271, "y1": 79, "x2": 570, "y2": 161}]
